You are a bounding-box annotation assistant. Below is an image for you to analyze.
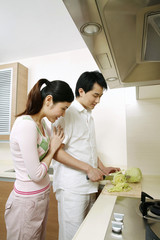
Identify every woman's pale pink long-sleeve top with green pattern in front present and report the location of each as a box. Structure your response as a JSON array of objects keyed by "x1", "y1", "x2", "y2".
[{"x1": 10, "y1": 115, "x2": 50, "y2": 196}]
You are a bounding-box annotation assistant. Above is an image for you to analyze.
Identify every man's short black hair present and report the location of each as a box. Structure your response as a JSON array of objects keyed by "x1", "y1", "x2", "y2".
[{"x1": 75, "y1": 71, "x2": 107, "y2": 97}]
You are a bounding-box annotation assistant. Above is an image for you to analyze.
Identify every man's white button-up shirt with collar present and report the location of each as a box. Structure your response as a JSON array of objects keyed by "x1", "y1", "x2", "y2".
[{"x1": 53, "y1": 100, "x2": 98, "y2": 194}]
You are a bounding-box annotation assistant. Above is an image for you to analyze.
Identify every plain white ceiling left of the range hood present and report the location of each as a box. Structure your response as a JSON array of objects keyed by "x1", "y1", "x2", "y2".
[{"x1": 0, "y1": 0, "x2": 86, "y2": 63}]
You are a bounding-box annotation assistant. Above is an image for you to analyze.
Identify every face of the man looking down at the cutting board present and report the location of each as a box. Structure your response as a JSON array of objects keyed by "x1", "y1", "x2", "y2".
[{"x1": 79, "y1": 83, "x2": 103, "y2": 110}]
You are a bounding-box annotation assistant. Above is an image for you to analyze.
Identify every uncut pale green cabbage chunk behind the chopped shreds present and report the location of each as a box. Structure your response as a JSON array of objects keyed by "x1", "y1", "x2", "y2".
[{"x1": 125, "y1": 167, "x2": 142, "y2": 183}]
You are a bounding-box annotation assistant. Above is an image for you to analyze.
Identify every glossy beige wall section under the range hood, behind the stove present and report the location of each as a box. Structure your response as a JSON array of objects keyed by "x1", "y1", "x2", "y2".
[{"x1": 126, "y1": 99, "x2": 160, "y2": 175}]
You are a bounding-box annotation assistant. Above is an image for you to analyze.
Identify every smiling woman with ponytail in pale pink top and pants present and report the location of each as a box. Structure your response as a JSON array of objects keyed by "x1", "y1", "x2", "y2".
[{"x1": 5, "y1": 79, "x2": 74, "y2": 240}]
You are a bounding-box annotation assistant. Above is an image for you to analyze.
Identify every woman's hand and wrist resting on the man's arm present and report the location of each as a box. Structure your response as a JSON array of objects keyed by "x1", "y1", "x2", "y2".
[{"x1": 50, "y1": 126, "x2": 64, "y2": 154}]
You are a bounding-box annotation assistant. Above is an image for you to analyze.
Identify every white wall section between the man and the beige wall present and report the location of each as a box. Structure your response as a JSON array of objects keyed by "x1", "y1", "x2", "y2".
[{"x1": 93, "y1": 89, "x2": 127, "y2": 168}]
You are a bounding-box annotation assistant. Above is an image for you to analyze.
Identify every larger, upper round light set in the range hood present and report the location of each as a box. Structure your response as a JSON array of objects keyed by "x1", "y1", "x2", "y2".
[{"x1": 80, "y1": 22, "x2": 102, "y2": 36}]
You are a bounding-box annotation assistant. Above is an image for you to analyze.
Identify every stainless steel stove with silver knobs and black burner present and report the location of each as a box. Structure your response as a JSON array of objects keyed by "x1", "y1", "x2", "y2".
[{"x1": 104, "y1": 192, "x2": 160, "y2": 240}]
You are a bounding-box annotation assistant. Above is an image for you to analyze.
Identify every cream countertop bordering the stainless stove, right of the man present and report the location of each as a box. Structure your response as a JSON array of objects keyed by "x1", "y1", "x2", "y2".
[{"x1": 73, "y1": 175, "x2": 160, "y2": 240}]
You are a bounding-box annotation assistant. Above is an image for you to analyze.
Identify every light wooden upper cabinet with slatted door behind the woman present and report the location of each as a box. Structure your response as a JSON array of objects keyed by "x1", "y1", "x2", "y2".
[{"x1": 0, "y1": 63, "x2": 28, "y2": 141}]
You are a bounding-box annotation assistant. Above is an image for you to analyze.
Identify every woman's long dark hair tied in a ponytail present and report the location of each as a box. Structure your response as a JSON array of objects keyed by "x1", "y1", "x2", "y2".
[{"x1": 17, "y1": 79, "x2": 74, "y2": 116}]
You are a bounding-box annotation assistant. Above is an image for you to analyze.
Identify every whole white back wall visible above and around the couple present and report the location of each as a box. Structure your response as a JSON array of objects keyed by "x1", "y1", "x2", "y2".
[{"x1": 0, "y1": 48, "x2": 126, "y2": 169}]
